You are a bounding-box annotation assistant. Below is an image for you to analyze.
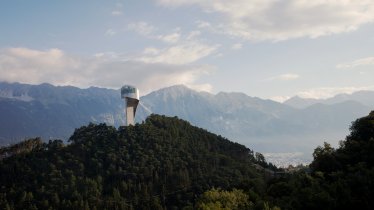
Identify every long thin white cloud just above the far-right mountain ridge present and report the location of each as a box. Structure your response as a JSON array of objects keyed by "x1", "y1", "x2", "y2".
[{"x1": 297, "y1": 86, "x2": 374, "y2": 99}]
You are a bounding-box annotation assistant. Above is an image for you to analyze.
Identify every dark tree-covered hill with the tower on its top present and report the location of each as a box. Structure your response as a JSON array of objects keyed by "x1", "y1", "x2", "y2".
[{"x1": 0, "y1": 115, "x2": 271, "y2": 209}]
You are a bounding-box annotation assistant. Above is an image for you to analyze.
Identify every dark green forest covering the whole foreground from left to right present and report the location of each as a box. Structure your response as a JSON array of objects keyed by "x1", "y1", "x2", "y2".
[{"x1": 0, "y1": 111, "x2": 374, "y2": 210}]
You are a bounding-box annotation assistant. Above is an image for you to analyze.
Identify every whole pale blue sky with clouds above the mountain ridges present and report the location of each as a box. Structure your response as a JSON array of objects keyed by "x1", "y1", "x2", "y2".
[{"x1": 0, "y1": 0, "x2": 374, "y2": 101}]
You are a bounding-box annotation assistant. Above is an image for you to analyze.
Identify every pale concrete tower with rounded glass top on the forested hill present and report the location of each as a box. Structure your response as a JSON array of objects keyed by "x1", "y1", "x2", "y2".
[{"x1": 121, "y1": 85, "x2": 139, "y2": 125}]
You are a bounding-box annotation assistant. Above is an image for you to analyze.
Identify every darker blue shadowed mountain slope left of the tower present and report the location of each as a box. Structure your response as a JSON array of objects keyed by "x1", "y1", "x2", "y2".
[{"x1": 0, "y1": 83, "x2": 123, "y2": 144}]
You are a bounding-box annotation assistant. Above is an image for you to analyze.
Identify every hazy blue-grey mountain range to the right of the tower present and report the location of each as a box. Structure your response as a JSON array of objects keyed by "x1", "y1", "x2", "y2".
[{"x1": 141, "y1": 86, "x2": 370, "y2": 152}]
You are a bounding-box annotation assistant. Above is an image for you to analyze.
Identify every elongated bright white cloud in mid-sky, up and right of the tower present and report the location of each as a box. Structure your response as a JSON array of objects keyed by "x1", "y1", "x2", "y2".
[{"x1": 137, "y1": 41, "x2": 219, "y2": 65}]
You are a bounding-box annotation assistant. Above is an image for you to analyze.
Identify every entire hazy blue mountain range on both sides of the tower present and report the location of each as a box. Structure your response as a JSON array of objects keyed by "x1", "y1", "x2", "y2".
[{"x1": 0, "y1": 83, "x2": 374, "y2": 160}]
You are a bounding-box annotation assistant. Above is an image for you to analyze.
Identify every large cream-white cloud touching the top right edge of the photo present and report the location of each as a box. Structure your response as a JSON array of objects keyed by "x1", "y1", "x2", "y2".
[{"x1": 158, "y1": 0, "x2": 374, "y2": 41}]
